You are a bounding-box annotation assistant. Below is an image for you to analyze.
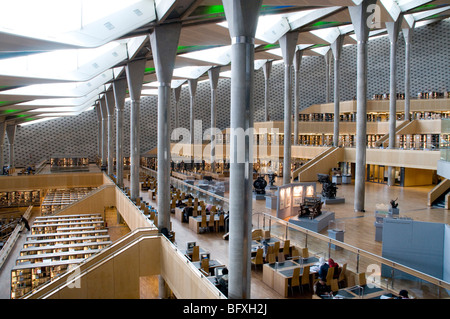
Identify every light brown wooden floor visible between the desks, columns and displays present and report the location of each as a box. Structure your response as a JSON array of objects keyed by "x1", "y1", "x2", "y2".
[{"x1": 132, "y1": 181, "x2": 450, "y2": 299}]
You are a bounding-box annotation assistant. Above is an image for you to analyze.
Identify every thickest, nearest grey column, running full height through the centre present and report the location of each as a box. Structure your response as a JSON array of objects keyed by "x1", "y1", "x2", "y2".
[{"x1": 223, "y1": 0, "x2": 262, "y2": 299}]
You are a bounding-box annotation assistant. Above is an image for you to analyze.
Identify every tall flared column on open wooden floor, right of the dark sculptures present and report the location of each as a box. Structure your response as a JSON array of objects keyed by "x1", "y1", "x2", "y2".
[{"x1": 348, "y1": 0, "x2": 376, "y2": 212}]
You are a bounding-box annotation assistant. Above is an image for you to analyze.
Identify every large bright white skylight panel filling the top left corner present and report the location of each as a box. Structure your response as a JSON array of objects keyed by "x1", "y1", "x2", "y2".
[{"x1": 0, "y1": 0, "x2": 156, "y2": 47}]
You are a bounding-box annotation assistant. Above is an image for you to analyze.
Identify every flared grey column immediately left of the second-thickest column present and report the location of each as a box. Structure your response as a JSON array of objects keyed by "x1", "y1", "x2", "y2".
[{"x1": 125, "y1": 59, "x2": 146, "y2": 200}]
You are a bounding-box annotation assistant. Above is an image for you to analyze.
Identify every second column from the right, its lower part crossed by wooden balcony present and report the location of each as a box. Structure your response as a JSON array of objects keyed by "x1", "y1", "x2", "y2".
[{"x1": 386, "y1": 15, "x2": 402, "y2": 186}]
